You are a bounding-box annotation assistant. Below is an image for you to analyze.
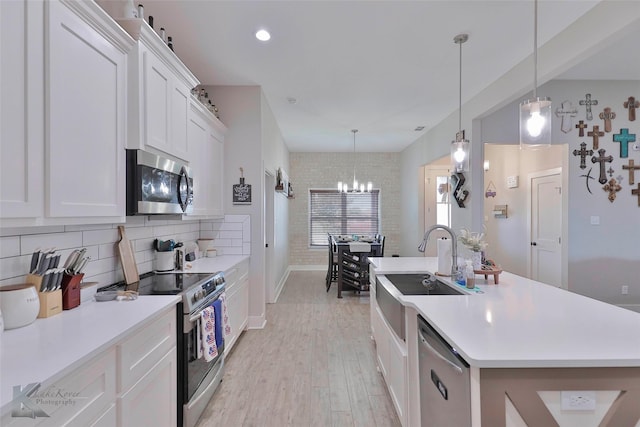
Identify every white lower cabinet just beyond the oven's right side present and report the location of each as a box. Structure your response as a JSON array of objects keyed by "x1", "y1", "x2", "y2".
[{"x1": 224, "y1": 260, "x2": 249, "y2": 355}]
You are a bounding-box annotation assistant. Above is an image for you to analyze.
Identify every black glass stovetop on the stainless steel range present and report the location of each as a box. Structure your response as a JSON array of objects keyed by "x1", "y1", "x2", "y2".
[{"x1": 98, "y1": 272, "x2": 212, "y2": 295}]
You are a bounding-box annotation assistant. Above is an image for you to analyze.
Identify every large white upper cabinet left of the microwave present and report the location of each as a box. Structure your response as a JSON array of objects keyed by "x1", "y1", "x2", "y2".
[{"x1": 0, "y1": 0, "x2": 133, "y2": 226}]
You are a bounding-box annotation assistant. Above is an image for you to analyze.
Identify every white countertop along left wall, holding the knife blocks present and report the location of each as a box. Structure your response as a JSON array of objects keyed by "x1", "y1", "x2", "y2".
[{"x1": 0, "y1": 295, "x2": 180, "y2": 414}]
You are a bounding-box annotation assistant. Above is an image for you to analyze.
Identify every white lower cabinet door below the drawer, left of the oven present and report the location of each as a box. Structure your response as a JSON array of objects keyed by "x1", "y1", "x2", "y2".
[{"x1": 117, "y1": 347, "x2": 178, "y2": 427}]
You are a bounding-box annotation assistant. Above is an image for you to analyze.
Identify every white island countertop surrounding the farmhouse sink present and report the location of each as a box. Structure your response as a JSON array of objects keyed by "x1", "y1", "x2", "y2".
[{"x1": 369, "y1": 257, "x2": 640, "y2": 368}]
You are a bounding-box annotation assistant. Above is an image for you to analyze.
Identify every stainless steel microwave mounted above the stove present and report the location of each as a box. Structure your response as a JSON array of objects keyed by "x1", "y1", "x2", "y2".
[{"x1": 127, "y1": 150, "x2": 193, "y2": 216}]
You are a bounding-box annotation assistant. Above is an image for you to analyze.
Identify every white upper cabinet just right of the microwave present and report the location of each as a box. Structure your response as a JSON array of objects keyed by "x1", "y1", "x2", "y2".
[{"x1": 187, "y1": 99, "x2": 226, "y2": 218}]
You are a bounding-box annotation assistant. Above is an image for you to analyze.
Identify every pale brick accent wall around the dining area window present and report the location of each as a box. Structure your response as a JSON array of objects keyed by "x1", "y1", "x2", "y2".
[{"x1": 288, "y1": 152, "x2": 401, "y2": 266}]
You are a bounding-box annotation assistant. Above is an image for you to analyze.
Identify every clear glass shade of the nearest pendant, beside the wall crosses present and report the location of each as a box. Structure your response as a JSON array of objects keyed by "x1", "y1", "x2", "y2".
[{"x1": 520, "y1": 97, "x2": 551, "y2": 149}]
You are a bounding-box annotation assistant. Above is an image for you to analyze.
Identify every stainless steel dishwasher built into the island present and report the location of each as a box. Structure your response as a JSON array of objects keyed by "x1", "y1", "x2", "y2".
[{"x1": 418, "y1": 315, "x2": 471, "y2": 427}]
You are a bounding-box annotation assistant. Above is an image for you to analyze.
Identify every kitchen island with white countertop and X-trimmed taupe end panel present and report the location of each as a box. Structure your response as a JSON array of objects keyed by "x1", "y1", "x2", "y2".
[{"x1": 370, "y1": 257, "x2": 640, "y2": 427}]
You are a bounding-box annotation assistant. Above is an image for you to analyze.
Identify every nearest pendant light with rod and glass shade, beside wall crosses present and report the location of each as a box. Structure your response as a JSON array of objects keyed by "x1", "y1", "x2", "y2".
[{"x1": 520, "y1": 0, "x2": 551, "y2": 149}]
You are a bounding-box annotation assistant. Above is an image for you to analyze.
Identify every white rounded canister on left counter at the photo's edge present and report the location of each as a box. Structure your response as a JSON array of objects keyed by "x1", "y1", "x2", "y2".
[{"x1": 0, "y1": 283, "x2": 40, "y2": 330}]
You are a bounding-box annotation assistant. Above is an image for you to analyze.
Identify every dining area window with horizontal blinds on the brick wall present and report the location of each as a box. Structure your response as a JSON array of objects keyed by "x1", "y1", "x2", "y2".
[{"x1": 309, "y1": 189, "x2": 380, "y2": 247}]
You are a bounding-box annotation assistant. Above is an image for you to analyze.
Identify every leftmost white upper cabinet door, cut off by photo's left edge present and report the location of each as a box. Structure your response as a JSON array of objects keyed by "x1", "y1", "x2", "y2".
[{"x1": 0, "y1": 0, "x2": 44, "y2": 218}]
